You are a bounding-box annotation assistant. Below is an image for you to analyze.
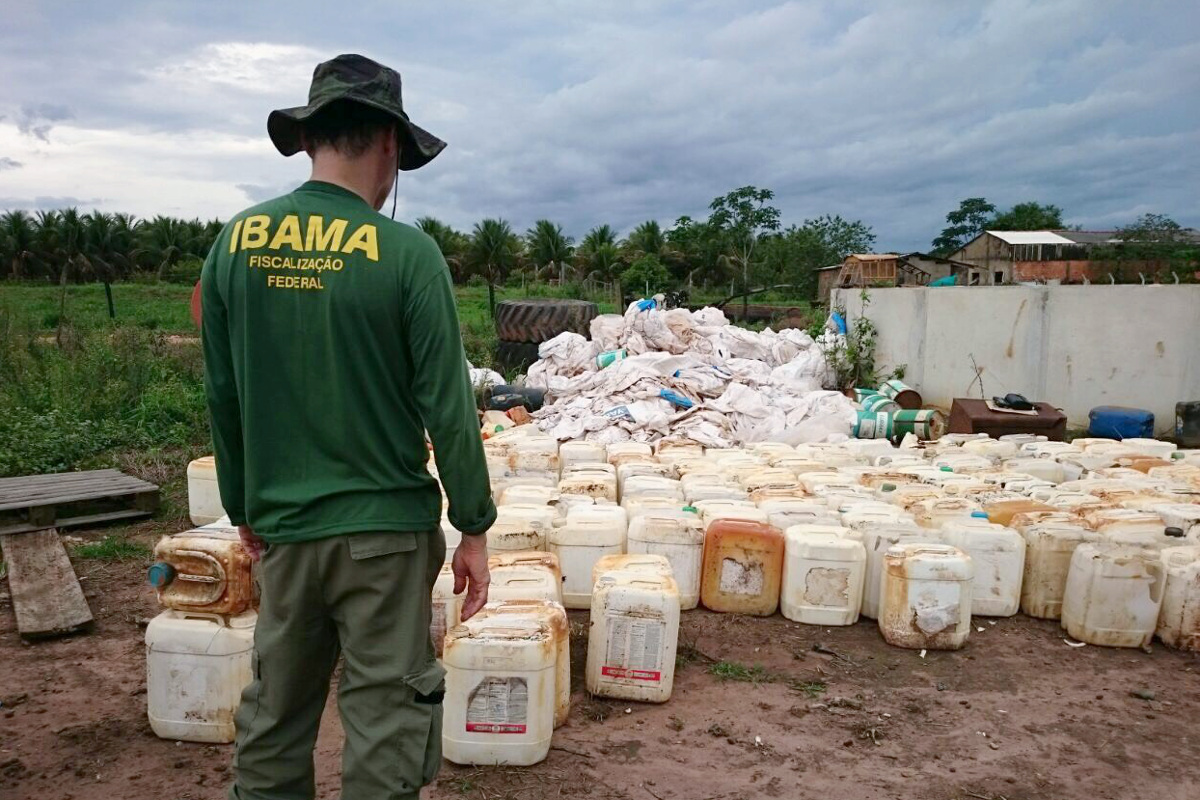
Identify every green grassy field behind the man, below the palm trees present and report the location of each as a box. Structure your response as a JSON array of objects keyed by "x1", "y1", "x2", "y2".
[{"x1": 0, "y1": 282, "x2": 616, "y2": 484}]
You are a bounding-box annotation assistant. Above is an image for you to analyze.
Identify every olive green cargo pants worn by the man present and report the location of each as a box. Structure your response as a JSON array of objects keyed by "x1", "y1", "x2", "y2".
[{"x1": 229, "y1": 531, "x2": 445, "y2": 800}]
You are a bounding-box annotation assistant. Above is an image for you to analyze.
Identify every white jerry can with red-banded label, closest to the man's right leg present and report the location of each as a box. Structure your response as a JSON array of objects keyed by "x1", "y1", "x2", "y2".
[{"x1": 442, "y1": 615, "x2": 558, "y2": 766}]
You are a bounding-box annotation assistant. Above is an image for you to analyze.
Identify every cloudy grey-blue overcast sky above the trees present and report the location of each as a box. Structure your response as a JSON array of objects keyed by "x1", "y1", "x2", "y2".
[{"x1": 0, "y1": 0, "x2": 1200, "y2": 251}]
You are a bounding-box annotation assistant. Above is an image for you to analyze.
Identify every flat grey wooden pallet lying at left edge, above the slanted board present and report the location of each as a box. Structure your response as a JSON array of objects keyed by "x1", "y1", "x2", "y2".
[{"x1": 0, "y1": 469, "x2": 158, "y2": 535}]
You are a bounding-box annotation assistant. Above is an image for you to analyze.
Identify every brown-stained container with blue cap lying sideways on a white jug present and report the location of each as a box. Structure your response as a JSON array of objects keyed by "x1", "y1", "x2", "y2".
[{"x1": 149, "y1": 524, "x2": 258, "y2": 614}]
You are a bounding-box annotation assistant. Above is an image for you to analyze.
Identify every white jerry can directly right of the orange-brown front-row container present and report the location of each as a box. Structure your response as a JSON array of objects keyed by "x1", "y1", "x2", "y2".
[{"x1": 779, "y1": 525, "x2": 866, "y2": 625}]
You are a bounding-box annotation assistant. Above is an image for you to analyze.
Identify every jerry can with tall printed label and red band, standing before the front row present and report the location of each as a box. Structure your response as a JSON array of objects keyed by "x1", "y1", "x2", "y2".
[{"x1": 587, "y1": 570, "x2": 679, "y2": 703}]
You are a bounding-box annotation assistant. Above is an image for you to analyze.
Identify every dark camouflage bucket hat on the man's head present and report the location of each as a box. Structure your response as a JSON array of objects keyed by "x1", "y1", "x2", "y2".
[{"x1": 266, "y1": 55, "x2": 446, "y2": 170}]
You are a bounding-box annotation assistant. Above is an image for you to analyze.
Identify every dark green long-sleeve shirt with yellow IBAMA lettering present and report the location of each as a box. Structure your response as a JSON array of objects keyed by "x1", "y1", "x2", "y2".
[{"x1": 200, "y1": 181, "x2": 496, "y2": 542}]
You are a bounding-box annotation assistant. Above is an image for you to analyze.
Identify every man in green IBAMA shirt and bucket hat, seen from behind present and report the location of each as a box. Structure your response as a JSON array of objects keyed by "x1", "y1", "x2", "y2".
[{"x1": 202, "y1": 55, "x2": 496, "y2": 800}]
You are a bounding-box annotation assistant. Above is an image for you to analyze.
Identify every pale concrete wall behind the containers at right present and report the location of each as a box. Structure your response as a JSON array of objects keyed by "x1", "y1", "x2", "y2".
[{"x1": 833, "y1": 284, "x2": 1200, "y2": 433}]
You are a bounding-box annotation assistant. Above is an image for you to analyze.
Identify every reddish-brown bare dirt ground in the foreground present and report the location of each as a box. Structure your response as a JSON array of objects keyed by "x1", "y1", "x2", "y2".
[{"x1": 0, "y1": 551, "x2": 1200, "y2": 800}]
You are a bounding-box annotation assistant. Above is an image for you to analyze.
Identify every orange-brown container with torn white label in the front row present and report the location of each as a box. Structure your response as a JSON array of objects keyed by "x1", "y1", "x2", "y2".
[{"x1": 700, "y1": 519, "x2": 784, "y2": 616}]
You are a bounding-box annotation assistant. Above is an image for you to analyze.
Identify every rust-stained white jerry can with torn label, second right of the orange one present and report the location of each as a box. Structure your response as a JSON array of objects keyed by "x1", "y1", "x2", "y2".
[{"x1": 880, "y1": 543, "x2": 974, "y2": 650}]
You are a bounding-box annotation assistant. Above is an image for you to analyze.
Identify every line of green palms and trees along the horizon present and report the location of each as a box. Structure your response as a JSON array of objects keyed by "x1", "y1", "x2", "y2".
[{"x1": 0, "y1": 186, "x2": 1200, "y2": 297}]
